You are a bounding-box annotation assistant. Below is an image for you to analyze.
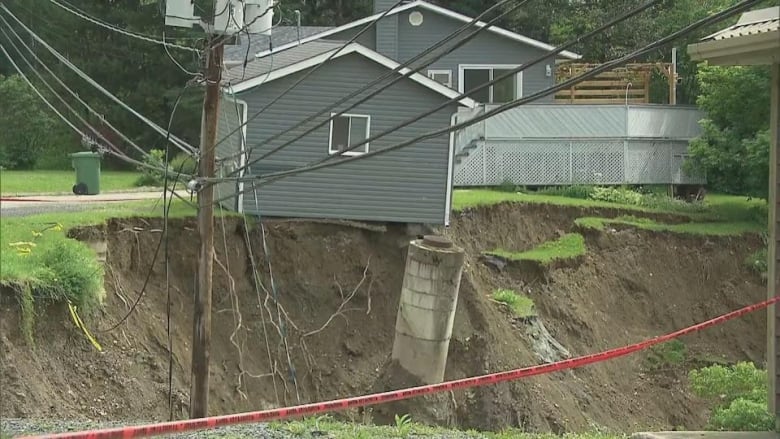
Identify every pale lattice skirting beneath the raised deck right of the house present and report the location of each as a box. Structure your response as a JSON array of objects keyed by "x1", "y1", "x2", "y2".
[{"x1": 454, "y1": 139, "x2": 706, "y2": 186}]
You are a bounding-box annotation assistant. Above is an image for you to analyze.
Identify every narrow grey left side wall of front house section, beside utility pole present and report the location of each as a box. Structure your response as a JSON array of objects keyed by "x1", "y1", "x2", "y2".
[{"x1": 214, "y1": 96, "x2": 244, "y2": 210}]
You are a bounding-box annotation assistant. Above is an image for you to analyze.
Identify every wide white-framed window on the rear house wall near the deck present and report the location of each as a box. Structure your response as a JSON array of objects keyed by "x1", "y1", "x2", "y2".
[{"x1": 458, "y1": 65, "x2": 523, "y2": 104}]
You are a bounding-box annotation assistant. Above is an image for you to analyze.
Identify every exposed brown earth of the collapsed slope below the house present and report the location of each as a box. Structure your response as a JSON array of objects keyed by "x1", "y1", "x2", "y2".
[{"x1": 0, "y1": 205, "x2": 766, "y2": 432}]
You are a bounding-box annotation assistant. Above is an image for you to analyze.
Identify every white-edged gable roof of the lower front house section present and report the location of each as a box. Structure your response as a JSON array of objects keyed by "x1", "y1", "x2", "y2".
[{"x1": 225, "y1": 41, "x2": 477, "y2": 108}]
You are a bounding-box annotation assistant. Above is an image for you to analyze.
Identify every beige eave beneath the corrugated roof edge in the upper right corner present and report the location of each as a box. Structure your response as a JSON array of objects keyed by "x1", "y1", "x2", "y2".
[{"x1": 688, "y1": 30, "x2": 780, "y2": 66}]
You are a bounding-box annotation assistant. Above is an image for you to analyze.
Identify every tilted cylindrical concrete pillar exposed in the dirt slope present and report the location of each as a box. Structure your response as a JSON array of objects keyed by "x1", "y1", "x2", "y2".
[{"x1": 392, "y1": 235, "x2": 465, "y2": 384}]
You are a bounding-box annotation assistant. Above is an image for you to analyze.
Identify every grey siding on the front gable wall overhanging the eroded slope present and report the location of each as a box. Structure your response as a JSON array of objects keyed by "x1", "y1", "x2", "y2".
[{"x1": 241, "y1": 54, "x2": 457, "y2": 224}]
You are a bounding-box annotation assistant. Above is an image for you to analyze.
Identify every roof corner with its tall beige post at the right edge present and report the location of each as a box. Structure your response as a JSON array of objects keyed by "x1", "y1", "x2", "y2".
[{"x1": 688, "y1": 7, "x2": 780, "y2": 430}]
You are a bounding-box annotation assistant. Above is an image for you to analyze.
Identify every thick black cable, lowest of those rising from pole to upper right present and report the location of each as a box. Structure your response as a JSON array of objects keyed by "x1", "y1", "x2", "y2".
[{"x1": 212, "y1": 0, "x2": 762, "y2": 205}]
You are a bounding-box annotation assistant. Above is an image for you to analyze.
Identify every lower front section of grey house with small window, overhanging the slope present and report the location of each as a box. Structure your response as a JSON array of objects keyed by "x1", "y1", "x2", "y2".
[{"x1": 217, "y1": 41, "x2": 475, "y2": 224}]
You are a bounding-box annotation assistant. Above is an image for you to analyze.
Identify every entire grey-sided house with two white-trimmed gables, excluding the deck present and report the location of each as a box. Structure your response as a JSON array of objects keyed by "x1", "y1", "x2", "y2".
[{"x1": 217, "y1": 0, "x2": 577, "y2": 224}]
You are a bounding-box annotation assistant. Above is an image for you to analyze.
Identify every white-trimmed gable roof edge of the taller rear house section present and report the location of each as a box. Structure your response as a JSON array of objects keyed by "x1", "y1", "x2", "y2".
[{"x1": 250, "y1": 0, "x2": 582, "y2": 59}]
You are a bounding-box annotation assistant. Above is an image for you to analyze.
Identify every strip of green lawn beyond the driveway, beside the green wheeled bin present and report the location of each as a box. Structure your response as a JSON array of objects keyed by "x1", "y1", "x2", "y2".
[{"x1": 0, "y1": 171, "x2": 145, "y2": 196}]
